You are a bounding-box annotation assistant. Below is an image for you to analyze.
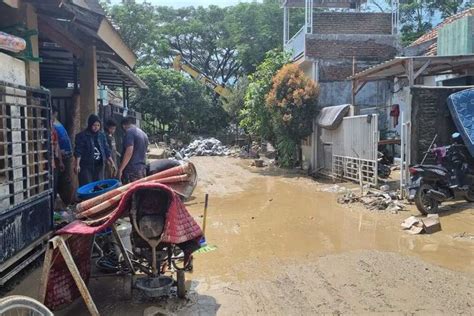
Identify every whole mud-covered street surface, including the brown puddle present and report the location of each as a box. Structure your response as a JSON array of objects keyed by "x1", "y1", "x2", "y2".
[{"x1": 7, "y1": 157, "x2": 474, "y2": 315}]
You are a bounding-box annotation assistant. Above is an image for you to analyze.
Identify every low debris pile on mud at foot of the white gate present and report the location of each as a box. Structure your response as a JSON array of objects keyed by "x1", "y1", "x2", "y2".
[{"x1": 337, "y1": 190, "x2": 405, "y2": 214}]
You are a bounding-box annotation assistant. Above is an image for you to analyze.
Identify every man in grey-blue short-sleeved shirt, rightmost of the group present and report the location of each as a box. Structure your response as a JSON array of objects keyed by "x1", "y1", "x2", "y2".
[{"x1": 118, "y1": 117, "x2": 148, "y2": 183}]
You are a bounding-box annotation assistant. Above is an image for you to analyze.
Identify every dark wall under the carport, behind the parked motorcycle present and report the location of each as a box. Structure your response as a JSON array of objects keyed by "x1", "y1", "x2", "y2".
[{"x1": 411, "y1": 88, "x2": 459, "y2": 163}]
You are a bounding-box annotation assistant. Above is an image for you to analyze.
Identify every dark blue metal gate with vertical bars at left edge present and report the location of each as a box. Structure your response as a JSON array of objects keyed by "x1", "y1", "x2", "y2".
[{"x1": 0, "y1": 81, "x2": 53, "y2": 285}]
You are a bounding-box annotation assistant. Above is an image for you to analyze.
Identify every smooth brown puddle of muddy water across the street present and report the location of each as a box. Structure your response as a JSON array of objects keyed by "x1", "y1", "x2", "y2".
[{"x1": 190, "y1": 176, "x2": 474, "y2": 279}]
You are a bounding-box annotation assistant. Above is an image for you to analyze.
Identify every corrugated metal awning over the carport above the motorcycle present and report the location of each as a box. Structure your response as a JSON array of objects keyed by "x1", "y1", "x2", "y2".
[{"x1": 349, "y1": 54, "x2": 474, "y2": 81}]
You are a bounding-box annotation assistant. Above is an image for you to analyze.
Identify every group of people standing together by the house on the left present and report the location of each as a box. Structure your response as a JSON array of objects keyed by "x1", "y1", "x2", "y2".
[{"x1": 51, "y1": 108, "x2": 148, "y2": 201}]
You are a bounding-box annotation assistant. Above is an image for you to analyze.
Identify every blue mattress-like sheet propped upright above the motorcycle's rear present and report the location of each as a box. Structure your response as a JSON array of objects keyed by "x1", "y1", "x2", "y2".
[{"x1": 448, "y1": 89, "x2": 474, "y2": 156}]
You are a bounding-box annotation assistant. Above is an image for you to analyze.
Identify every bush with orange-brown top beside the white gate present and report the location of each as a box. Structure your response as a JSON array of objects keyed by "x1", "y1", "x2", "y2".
[{"x1": 266, "y1": 64, "x2": 319, "y2": 167}]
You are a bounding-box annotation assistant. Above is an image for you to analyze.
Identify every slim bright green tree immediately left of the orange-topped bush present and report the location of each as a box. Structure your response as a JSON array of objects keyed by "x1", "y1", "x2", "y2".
[{"x1": 240, "y1": 50, "x2": 290, "y2": 141}]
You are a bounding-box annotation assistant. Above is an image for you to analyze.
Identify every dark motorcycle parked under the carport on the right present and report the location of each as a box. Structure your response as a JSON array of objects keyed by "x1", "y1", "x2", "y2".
[{"x1": 407, "y1": 133, "x2": 474, "y2": 215}]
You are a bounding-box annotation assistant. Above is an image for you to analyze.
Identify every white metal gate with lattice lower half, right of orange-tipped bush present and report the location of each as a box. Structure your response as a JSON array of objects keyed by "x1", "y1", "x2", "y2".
[{"x1": 321, "y1": 115, "x2": 379, "y2": 186}]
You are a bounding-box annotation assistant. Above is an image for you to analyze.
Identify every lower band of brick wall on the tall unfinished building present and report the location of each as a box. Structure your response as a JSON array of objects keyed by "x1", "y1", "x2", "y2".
[{"x1": 306, "y1": 34, "x2": 397, "y2": 62}]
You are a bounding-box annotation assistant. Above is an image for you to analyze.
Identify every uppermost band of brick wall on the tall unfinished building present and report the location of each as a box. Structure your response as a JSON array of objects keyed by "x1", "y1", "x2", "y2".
[{"x1": 313, "y1": 12, "x2": 392, "y2": 35}]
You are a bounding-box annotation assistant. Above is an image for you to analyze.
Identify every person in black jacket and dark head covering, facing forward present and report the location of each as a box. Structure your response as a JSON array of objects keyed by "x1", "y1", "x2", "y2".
[{"x1": 74, "y1": 114, "x2": 115, "y2": 186}]
